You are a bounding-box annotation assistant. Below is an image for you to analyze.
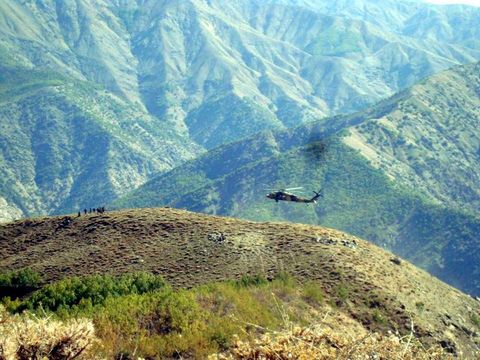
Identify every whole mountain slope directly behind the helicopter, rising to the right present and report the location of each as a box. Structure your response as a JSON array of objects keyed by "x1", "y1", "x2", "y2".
[{"x1": 115, "y1": 64, "x2": 480, "y2": 294}]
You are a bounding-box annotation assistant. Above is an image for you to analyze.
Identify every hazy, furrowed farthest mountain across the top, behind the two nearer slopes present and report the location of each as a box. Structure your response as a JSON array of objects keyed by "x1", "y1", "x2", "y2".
[{"x1": 0, "y1": 0, "x2": 480, "y2": 148}]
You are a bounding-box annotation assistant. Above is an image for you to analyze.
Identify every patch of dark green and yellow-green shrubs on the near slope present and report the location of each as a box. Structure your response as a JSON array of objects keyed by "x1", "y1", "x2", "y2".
[{"x1": 8, "y1": 273, "x2": 338, "y2": 359}]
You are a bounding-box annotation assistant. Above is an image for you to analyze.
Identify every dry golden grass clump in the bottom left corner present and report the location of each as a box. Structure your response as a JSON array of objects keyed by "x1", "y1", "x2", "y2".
[{"x1": 0, "y1": 307, "x2": 96, "y2": 360}]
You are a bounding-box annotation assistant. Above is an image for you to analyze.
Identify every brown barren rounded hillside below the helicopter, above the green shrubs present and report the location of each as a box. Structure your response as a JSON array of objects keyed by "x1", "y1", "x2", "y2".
[{"x1": 0, "y1": 208, "x2": 480, "y2": 358}]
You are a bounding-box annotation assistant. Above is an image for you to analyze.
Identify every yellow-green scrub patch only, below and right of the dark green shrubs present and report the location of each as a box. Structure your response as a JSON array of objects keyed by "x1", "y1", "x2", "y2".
[{"x1": 84, "y1": 276, "x2": 300, "y2": 359}]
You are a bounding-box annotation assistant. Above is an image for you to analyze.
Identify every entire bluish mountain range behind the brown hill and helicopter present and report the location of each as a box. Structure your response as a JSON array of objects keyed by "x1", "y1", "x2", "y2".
[{"x1": 0, "y1": 0, "x2": 480, "y2": 294}]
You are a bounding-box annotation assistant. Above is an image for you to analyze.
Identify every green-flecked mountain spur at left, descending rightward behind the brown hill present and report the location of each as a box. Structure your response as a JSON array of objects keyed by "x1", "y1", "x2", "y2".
[{"x1": 0, "y1": 68, "x2": 199, "y2": 220}]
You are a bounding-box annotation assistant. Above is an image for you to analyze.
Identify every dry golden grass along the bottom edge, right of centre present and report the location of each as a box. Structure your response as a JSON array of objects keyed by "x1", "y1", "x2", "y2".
[{"x1": 209, "y1": 326, "x2": 452, "y2": 360}]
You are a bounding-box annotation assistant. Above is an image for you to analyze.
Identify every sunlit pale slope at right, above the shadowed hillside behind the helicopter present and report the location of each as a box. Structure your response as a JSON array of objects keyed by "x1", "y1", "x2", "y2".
[{"x1": 343, "y1": 63, "x2": 480, "y2": 214}]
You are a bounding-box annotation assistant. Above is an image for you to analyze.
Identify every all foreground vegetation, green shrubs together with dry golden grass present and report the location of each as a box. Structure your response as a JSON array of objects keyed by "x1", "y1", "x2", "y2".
[{"x1": 0, "y1": 273, "x2": 458, "y2": 360}]
